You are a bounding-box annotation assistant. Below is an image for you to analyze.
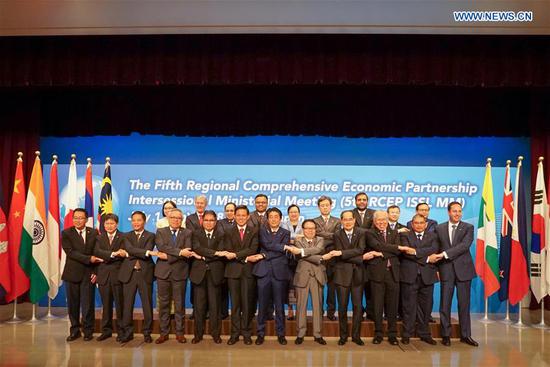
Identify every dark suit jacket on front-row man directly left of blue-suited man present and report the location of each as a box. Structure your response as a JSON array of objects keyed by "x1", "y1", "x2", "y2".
[{"x1": 224, "y1": 225, "x2": 263, "y2": 279}]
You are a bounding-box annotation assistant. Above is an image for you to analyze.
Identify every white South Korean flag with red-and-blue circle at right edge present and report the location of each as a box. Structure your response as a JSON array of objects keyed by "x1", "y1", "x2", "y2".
[{"x1": 531, "y1": 157, "x2": 548, "y2": 302}]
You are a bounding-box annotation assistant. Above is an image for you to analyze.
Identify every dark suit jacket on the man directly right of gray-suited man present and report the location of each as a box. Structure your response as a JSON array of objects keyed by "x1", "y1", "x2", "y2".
[{"x1": 334, "y1": 227, "x2": 365, "y2": 287}]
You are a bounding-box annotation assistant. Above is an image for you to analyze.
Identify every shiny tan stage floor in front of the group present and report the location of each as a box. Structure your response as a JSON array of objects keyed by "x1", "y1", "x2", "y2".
[{"x1": 0, "y1": 304, "x2": 550, "y2": 367}]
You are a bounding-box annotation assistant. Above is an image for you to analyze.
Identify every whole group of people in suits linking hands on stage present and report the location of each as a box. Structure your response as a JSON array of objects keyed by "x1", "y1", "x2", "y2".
[{"x1": 62, "y1": 193, "x2": 477, "y2": 346}]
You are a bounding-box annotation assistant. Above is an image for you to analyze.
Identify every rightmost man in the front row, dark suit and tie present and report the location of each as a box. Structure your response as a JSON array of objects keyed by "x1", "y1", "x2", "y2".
[{"x1": 429, "y1": 201, "x2": 478, "y2": 347}]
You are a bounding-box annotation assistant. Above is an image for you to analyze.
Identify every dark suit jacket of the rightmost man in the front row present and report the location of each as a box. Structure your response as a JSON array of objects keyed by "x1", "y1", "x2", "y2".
[{"x1": 436, "y1": 221, "x2": 476, "y2": 281}]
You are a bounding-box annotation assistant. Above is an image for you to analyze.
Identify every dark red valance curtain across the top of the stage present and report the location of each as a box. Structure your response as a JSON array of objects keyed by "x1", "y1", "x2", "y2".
[{"x1": 0, "y1": 34, "x2": 550, "y2": 87}]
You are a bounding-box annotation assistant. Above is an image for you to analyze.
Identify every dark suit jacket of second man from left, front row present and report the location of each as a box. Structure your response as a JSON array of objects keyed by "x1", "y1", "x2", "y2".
[{"x1": 94, "y1": 230, "x2": 124, "y2": 285}]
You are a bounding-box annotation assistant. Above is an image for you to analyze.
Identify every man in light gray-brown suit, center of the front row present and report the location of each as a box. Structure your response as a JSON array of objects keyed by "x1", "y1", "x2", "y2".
[{"x1": 285, "y1": 219, "x2": 327, "y2": 345}]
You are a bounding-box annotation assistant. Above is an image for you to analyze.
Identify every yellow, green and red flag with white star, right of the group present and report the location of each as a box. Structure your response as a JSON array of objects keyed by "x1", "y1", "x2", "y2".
[{"x1": 476, "y1": 158, "x2": 500, "y2": 298}]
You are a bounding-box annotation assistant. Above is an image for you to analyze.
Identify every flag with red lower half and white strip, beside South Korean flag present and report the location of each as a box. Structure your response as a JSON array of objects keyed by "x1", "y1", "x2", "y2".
[{"x1": 508, "y1": 156, "x2": 529, "y2": 305}]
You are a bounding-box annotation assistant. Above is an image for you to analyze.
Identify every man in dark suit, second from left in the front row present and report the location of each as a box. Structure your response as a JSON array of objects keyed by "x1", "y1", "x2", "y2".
[{"x1": 94, "y1": 213, "x2": 127, "y2": 341}]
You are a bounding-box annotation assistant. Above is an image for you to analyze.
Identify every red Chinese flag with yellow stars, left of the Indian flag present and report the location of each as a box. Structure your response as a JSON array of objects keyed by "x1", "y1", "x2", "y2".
[{"x1": 6, "y1": 152, "x2": 30, "y2": 302}]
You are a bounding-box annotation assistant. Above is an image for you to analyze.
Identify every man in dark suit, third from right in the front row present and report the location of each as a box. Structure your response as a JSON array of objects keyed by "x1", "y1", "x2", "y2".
[{"x1": 366, "y1": 210, "x2": 404, "y2": 345}]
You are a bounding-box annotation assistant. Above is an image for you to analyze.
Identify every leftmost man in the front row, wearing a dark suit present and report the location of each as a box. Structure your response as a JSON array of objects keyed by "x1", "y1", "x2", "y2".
[{"x1": 61, "y1": 208, "x2": 103, "y2": 342}]
